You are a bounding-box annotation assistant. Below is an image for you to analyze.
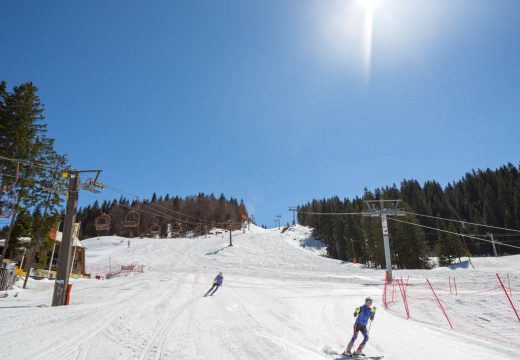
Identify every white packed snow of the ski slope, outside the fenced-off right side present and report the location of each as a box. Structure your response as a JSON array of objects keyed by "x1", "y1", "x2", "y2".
[{"x1": 0, "y1": 226, "x2": 520, "y2": 360}]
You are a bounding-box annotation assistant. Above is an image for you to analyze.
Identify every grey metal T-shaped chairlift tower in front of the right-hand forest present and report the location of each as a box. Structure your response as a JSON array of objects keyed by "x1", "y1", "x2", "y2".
[{"x1": 363, "y1": 200, "x2": 406, "y2": 281}]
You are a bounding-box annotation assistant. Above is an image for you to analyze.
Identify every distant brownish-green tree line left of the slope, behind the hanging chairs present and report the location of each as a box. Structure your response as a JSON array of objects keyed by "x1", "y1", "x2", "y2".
[{"x1": 76, "y1": 193, "x2": 249, "y2": 239}]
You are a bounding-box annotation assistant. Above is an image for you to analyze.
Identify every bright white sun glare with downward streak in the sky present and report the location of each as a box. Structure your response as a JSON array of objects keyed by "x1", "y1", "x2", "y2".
[{"x1": 304, "y1": 0, "x2": 469, "y2": 89}]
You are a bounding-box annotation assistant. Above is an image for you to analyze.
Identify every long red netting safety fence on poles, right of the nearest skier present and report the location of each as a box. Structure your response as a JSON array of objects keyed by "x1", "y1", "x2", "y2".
[{"x1": 382, "y1": 274, "x2": 520, "y2": 348}]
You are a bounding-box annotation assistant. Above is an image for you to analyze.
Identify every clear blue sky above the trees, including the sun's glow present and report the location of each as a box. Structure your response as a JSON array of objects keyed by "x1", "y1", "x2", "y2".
[{"x1": 0, "y1": 0, "x2": 520, "y2": 226}]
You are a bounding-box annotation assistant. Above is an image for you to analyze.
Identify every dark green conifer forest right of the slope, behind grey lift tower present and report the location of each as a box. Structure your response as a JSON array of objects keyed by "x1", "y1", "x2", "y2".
[{"x1": 298, "y1": 164, "x2": 520, "y2": 268}]
